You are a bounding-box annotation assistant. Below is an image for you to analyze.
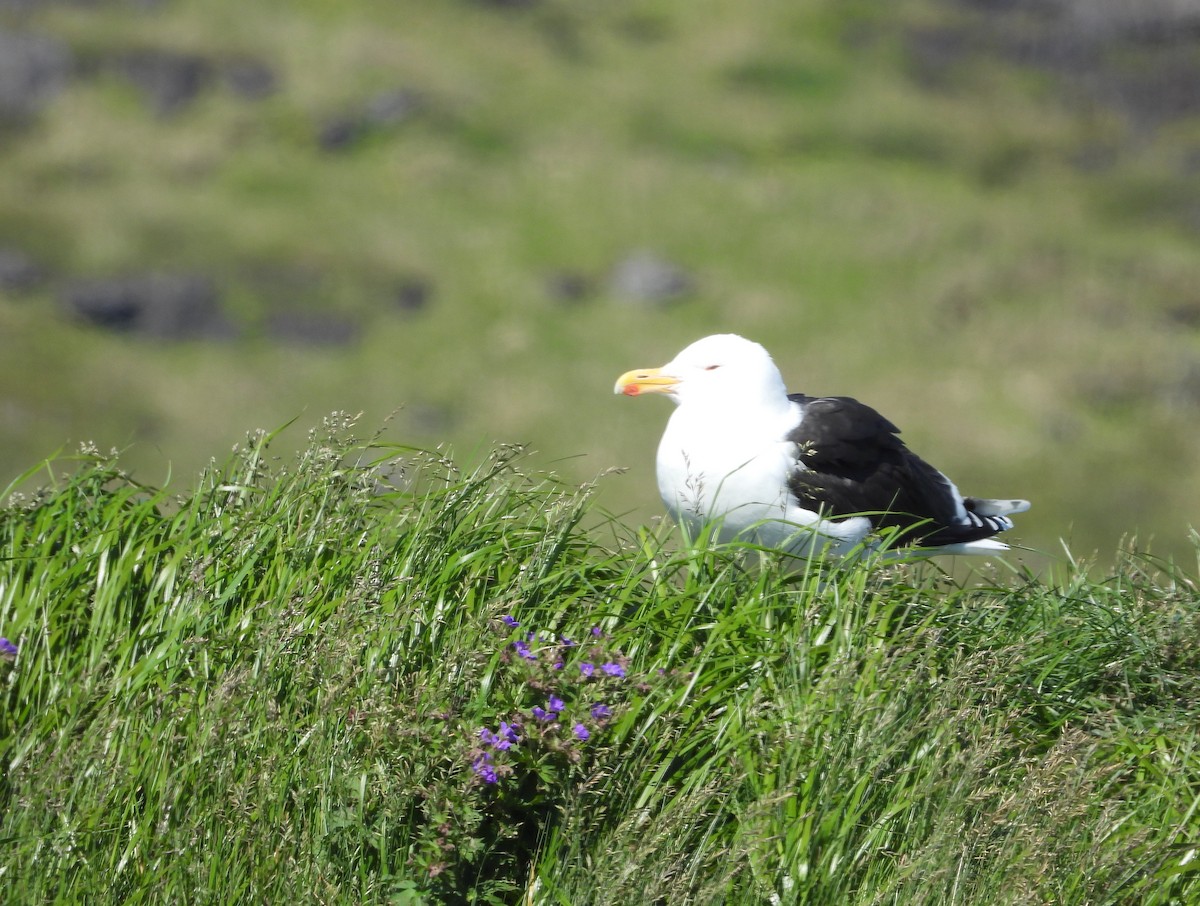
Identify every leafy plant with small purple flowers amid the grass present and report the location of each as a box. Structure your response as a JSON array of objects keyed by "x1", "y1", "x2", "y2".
[{"x1": 409, "y1": 614, "x2": 684, "y2": 902}]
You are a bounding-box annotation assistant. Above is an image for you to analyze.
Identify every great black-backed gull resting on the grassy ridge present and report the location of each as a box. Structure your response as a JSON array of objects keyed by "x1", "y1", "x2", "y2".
[{"x1": 616, "y1": 334, "x2": 1030, "y2": 557}]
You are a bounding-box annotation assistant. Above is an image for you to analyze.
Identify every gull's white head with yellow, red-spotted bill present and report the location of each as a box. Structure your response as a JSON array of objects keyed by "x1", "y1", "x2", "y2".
[{"x1": 613, "y1": 334, "x2": 787, "y2": 407}]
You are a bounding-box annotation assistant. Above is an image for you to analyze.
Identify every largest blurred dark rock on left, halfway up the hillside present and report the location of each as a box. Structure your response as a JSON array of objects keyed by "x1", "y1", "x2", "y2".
[{"x1": 60, "y1": 274, "x2": 234, "y2": 340}]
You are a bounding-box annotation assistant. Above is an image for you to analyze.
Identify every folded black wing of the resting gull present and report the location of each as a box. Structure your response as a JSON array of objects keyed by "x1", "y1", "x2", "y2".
[{"x1": 787, "y1": 394, "x2": 1007, "y2": 547}]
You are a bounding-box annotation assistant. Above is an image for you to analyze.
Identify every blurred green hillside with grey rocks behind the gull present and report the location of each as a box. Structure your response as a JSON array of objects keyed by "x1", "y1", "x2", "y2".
[{"x1": 0, "y1": 0, "x2": 1200, "y2": 563}]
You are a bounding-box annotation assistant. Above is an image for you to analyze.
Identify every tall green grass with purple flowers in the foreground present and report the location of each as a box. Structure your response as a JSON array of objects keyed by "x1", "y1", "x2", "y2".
[{"x1": 0, "y1": 415, "x2": 1200, "y2": 906}]
